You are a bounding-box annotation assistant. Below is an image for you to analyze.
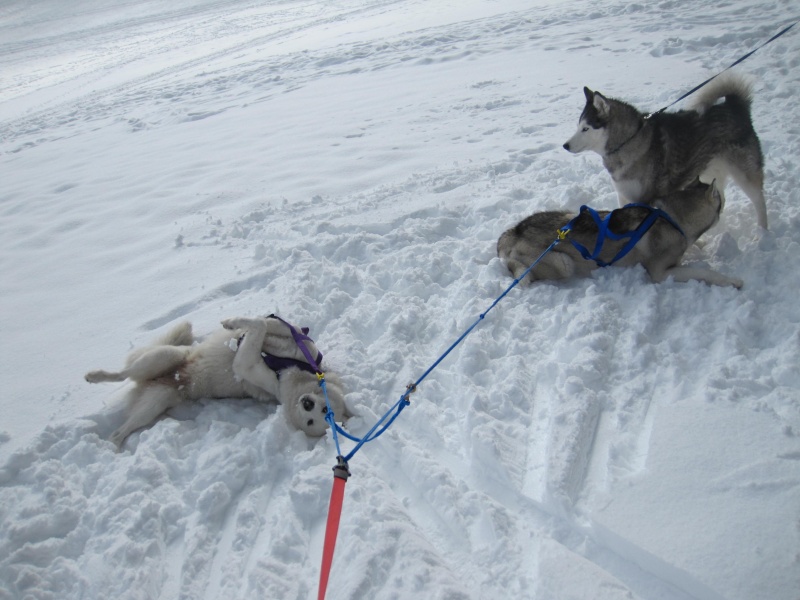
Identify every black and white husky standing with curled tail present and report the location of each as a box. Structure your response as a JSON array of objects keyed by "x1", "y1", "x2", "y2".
[{"x1": 564, "y1": 74, "x2": 767, "y2": 229}]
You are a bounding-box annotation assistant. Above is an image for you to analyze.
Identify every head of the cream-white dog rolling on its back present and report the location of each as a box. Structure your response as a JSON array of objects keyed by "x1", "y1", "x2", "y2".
[{"x1": 279, "y1": 367, "x2": 353, "y2": 437}]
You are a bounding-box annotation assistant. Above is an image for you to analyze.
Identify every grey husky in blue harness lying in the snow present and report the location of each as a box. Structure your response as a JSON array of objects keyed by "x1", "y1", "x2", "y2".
[{"x1": 497, "y1": 180, "x2": 742, "y2": 288}]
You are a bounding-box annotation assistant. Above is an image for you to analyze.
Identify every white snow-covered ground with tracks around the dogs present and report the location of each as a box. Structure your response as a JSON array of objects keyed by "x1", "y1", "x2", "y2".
[{"x1": 0, "y1": 0, "x2": 800, "y2": 600}]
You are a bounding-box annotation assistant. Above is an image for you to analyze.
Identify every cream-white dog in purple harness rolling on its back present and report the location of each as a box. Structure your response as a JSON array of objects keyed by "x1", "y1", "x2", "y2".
[{"x1": 86, "y1": 317, "x2": 352, "y2": 447}]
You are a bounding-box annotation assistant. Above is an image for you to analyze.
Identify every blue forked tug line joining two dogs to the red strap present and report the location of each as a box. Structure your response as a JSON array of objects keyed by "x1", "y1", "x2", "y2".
[{"x1": 317, "y1": 234, "x2": 569, "y2": 463}]
